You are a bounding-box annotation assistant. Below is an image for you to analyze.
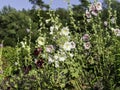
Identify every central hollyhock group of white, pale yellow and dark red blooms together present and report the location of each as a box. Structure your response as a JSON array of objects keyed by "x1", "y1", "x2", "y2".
[{"x1": 34, "y1": 25, "x2": 76, "y2": 67}]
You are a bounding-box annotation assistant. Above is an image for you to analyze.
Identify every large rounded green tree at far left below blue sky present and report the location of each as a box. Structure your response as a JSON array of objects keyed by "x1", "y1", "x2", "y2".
[{"x1": 0, "y1": 6, "x2": 38, "y2": 46}]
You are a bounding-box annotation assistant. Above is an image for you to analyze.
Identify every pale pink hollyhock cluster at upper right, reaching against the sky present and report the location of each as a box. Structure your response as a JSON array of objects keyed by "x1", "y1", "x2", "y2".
[{"x1": 85, "y1": 2, "x2": 102, "y2": 21}]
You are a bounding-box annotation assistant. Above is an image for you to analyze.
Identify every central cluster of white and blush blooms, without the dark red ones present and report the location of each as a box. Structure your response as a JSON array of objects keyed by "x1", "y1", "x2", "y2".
[{"x1": 45, "y1": 25, "x2": 76, "y2": 67}]
